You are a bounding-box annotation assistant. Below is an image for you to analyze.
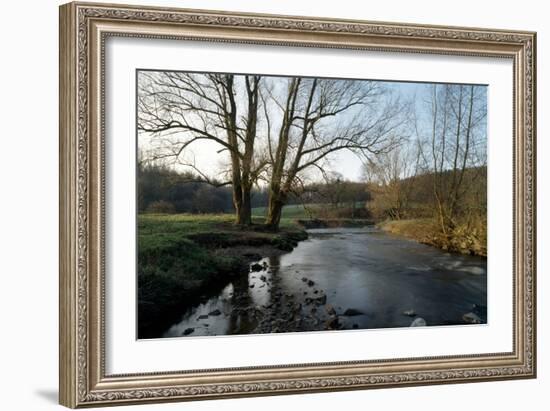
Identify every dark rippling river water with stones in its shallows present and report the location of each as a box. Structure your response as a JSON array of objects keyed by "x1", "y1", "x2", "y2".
[{"x1": 163, "y1": 227, "x2": 487, "y2": 337}]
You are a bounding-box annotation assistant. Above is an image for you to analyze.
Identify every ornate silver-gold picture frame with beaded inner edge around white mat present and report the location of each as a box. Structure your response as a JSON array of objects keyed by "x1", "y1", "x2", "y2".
[{"x1": 60, "y1": 3, "x2": 536, "y2": 408}]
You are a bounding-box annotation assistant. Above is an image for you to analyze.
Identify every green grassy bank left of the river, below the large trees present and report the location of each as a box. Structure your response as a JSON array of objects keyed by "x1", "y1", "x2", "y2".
[{"x1": 138, "y1": 214, "x2": 307, "y2": 338}]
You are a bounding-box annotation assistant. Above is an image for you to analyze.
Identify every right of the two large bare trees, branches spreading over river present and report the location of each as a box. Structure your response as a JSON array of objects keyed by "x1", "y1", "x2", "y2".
[{"x1": 261, "y1": 77, "x2": 407, "y2": 229}]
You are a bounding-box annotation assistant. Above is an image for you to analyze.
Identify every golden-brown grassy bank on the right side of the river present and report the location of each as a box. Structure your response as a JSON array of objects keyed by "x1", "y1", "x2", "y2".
[{"x1": 377, "y1": 218, "x2": 487, "y2": 257}]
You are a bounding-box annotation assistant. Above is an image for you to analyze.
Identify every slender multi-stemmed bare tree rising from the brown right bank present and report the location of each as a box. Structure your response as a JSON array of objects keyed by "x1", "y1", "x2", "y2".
[{"x1": 417, "y1": 84, "x2": 487, "y2": 236}]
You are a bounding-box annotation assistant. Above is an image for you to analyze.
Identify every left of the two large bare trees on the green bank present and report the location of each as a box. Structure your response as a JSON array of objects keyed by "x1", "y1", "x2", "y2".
[{"x1": 138, "y1": 71, "x2": 267, "y2": 225}]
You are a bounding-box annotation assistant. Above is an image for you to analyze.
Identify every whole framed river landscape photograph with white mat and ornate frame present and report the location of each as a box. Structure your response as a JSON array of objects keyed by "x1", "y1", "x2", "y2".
[{"x1": 60, "y1": 3, "x2": 536, "y2": 408}]
